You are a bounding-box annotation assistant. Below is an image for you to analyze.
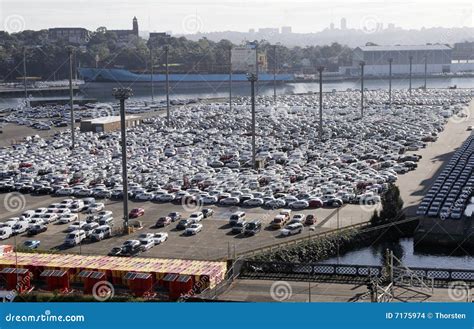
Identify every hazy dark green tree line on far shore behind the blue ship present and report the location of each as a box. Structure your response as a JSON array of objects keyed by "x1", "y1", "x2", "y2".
[{"x1": 0, "y1": 28, "x2": 352, "y2": 81}]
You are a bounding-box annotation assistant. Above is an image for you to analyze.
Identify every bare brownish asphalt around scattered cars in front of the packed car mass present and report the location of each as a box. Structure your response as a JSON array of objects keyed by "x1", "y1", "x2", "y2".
[{"x1": 0, "y1": 196, "x2": 370, "y2": 260}]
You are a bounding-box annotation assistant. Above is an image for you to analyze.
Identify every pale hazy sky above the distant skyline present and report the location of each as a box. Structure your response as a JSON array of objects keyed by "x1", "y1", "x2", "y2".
[{"x1": 0, "y1": 0, "x2": 474, "y2": 33}]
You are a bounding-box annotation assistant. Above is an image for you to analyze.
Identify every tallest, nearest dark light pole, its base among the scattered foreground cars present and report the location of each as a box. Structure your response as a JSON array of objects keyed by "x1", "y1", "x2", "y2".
[{"x1": 112, "y1": 88, "x2": 133, "y2": 234}]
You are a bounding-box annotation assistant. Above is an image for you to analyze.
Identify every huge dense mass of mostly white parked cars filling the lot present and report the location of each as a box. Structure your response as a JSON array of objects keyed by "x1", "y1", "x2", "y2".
[{"x1": 0, "y1": 90, "x2": 471, "y2": 213}]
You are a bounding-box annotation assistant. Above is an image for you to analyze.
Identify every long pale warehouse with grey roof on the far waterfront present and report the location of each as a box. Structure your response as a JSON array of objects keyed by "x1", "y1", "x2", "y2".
[{"x1": 340, "y1": 45, "x2": 453, "y2": 76}]
